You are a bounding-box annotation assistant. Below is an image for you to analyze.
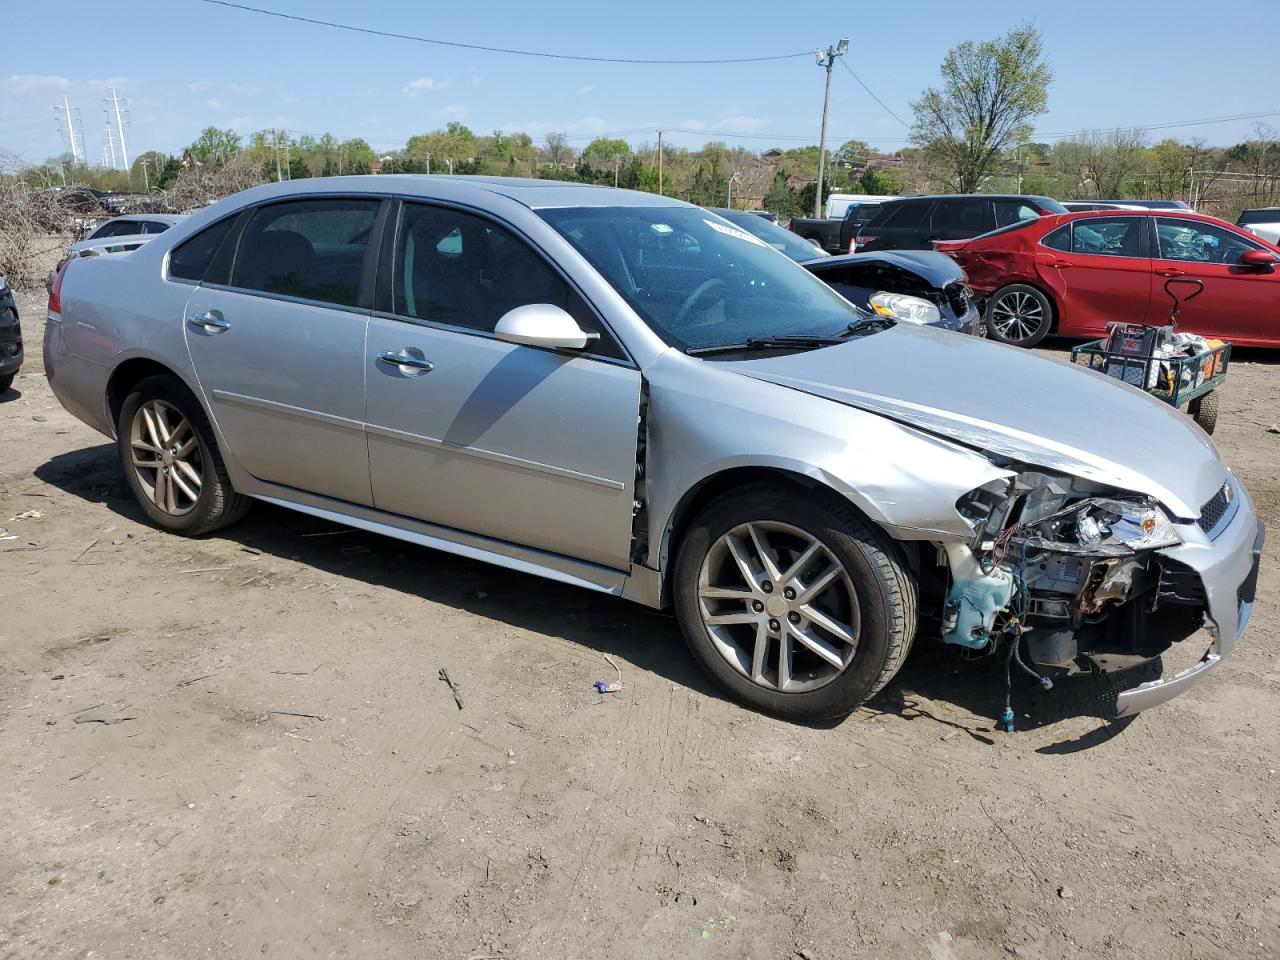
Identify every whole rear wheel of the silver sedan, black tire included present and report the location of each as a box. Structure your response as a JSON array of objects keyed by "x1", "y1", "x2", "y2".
[{"x1": 115, "y1": 375, "x2": 252, "y2": 536}]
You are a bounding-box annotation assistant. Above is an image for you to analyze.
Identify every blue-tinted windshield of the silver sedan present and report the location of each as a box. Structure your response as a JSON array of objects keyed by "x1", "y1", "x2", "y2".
[{"x1": 538, "y1": 206, "x2": 863, "y2": 349}]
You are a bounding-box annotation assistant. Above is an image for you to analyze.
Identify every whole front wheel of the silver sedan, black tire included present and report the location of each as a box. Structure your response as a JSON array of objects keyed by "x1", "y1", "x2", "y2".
[{"x1": 673, "y1": 485, "x2": 918, "y2": 722}]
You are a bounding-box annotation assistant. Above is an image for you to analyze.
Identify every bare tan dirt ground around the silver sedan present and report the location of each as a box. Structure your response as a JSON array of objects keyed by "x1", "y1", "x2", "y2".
[{"x1": 0, "y1": 288, "x2": 1280, "y2": 960}]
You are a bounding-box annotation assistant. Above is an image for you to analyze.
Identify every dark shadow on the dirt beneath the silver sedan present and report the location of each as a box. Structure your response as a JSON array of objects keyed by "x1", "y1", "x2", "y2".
[{"x1": 36, "y1": 444, "x2": 1141, "y2": 753}]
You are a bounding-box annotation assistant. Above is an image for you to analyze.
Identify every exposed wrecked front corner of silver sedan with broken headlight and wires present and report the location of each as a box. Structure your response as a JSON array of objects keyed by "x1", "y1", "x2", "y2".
[{"x1": 941, "y1": 465, "x2": 1206, "y2": 723}]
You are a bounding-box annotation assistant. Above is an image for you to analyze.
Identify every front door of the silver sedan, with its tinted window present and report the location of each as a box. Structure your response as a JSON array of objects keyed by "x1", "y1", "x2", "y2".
[{"x1": 365, "y1": 201, "x2": 640, "y2": 570}]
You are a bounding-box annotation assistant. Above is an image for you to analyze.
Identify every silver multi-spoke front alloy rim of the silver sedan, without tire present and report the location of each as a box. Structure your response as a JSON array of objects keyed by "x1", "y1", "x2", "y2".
[{"x1": 698, "y1": 521, "x2": 860, "y2": 694}]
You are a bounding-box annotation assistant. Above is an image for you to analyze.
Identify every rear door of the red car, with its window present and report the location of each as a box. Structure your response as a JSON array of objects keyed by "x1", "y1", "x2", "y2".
[{"x1": 1036, "y1": 216, "x2": 1151, "y2": 337}]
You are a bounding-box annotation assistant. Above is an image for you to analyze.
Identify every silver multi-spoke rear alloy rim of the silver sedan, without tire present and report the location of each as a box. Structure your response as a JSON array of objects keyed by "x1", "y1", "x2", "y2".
[{"x1": 129, "y1": 399, "x2": 205, "y2": 517}]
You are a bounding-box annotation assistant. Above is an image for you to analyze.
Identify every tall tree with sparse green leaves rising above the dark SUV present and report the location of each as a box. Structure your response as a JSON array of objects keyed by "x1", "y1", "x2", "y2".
[{"x1": 911, "y1": 24, "x2": 1053, "y2": 193}]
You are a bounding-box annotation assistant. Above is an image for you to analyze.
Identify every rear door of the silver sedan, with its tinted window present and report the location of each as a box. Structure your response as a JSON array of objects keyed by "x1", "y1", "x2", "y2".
[{"x1": 183, "y1": 197, "x2": 384, "y2": 504}]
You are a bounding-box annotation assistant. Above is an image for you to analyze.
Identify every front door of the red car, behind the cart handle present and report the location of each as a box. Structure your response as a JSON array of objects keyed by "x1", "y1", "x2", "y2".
[{"x1": 1152, "y1": 216, "x2": 1280, "y2": 344}]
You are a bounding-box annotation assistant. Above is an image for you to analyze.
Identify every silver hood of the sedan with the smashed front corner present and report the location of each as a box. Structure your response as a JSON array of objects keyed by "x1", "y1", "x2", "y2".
[{"x1": 733, "y1": 324, "x2": 1226, "y2": 520}]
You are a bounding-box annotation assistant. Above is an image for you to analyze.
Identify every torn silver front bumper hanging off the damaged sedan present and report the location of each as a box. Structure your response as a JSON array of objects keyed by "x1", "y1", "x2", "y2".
[{"x1": 1116, "y1": 481, "x2": 1266, "y2": 718}]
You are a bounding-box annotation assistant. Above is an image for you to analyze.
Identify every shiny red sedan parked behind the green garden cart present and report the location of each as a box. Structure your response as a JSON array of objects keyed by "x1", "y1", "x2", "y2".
[{"x1": 934, "y1": 210, "x2": 1280, "y2": 347}]
